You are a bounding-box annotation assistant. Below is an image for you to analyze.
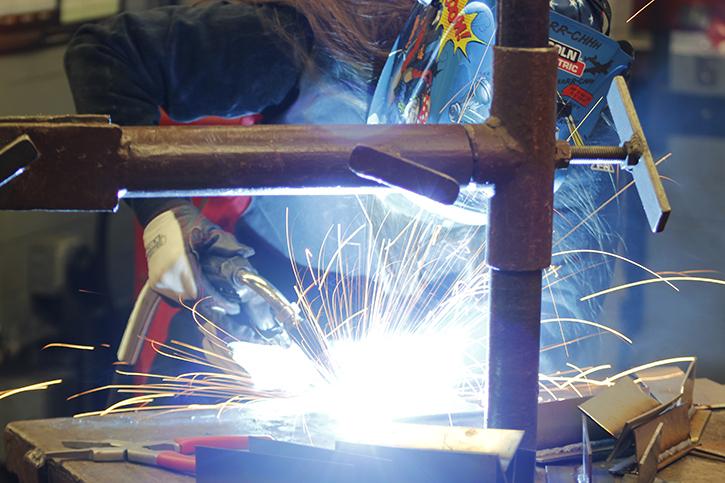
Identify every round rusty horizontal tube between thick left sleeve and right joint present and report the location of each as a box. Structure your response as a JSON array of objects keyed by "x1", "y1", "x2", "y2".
[{"x1": 117, "y1": 125, "x2": 473, "y2": 197}]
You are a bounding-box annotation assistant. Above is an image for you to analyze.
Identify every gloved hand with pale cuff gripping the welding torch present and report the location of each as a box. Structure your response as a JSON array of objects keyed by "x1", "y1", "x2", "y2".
[{"x1": 144, "y1": 203, "x2": 291, "y2": 346}]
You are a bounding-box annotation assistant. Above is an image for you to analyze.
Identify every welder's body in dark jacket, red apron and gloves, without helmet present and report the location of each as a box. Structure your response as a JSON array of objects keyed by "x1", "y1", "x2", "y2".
[{"x1": 65, "y1": 0, "x2": 608, "y2": 378}]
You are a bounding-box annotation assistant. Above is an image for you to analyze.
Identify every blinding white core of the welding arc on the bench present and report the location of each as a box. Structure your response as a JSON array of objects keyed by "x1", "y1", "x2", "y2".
[{"x1": 230, "y1": 334, "x2": 472, "y2": 434}]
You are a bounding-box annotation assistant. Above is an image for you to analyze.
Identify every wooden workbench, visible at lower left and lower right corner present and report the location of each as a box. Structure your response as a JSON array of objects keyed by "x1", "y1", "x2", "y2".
[{"x1": 5, "y1": 411, "x2": 725, "y2": 483}]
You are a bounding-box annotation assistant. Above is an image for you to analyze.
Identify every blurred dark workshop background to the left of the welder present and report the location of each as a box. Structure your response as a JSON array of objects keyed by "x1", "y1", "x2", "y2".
[{"x1": 0, "y1": 0, "x2": 184, "y2": 472}]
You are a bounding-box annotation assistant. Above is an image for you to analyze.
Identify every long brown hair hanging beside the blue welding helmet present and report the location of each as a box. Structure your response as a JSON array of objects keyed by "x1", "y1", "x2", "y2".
[{"x1": 201, "y1": 0, "x2": 417, "y2": 74}]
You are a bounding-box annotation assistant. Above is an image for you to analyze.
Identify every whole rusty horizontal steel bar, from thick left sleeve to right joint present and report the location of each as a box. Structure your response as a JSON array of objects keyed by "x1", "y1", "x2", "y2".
[{"x1": 0, "y1": 116, "x2": 536, "y2": 211}]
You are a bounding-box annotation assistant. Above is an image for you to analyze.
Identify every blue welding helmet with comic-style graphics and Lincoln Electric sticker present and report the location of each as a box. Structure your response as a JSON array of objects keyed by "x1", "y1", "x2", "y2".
[{"x1": 368, "y1": 0, "x2": 632, "y2": 219}]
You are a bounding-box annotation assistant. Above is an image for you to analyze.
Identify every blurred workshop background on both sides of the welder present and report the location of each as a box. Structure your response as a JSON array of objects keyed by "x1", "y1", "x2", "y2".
[{"x1": 0, "y1": 0, "x2": 725, "y2": 476}]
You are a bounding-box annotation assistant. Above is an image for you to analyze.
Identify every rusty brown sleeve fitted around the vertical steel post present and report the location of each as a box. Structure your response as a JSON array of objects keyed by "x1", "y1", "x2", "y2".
[{"x1": 488, "y1": 47, "x2": 557, "y2": 271}]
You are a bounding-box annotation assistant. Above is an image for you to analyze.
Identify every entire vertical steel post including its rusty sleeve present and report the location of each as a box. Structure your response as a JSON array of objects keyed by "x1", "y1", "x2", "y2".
[{"x1": 486, "y1": 0, "x2": 556, "y2": 481}]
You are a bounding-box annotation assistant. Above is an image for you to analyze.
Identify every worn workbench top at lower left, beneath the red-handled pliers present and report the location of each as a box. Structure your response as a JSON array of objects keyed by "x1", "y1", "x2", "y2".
[{"x1": 5, "y1": 410, "x2": 332, "y2": 483}]
